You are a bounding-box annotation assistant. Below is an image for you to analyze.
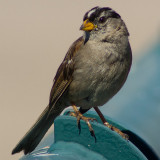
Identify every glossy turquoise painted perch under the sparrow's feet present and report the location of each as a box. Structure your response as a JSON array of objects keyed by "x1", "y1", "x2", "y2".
[{"x1": 21, "y1": 111, "x2": 147, "y2": 160}]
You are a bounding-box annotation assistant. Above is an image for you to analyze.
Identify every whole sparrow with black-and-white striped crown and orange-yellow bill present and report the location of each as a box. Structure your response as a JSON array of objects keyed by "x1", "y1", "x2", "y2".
[{"x1": 12, "y1": 6, "x2": 132, "y2": 154}]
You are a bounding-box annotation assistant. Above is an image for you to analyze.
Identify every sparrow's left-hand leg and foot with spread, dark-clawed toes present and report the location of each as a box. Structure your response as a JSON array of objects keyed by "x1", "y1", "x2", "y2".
[{"x1": 70, "y1": 105, "x2": 96, "y2": 139}]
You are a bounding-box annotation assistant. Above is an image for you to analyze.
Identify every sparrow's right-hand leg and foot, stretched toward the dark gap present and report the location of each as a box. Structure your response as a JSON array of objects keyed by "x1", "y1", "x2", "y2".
[{"x1": 94, "y1": 107, "x2": 129, "y2": 140}]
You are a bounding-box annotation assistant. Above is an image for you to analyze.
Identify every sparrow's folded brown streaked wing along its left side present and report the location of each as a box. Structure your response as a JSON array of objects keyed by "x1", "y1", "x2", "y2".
[{"x1": 49, "y1": 37, "x2": 84, "y2": 109}]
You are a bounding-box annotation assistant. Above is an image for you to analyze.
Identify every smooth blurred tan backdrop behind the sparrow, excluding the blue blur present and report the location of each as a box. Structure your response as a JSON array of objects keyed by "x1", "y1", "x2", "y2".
[{"x1": 0, "y1": 0, "x2": 160, "y2": 160}]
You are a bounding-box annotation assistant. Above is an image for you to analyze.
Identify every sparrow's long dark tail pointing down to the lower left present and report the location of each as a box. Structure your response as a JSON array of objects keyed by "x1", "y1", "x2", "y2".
[{"x1": 12, "y1": 106, "x2": 61, "y2": 154}]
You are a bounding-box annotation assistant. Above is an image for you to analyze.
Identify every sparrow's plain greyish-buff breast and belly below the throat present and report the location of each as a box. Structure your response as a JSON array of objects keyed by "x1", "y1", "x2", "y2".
[{"x1": 69, "y1": 41, "x2": 129, "y2": 108}]
